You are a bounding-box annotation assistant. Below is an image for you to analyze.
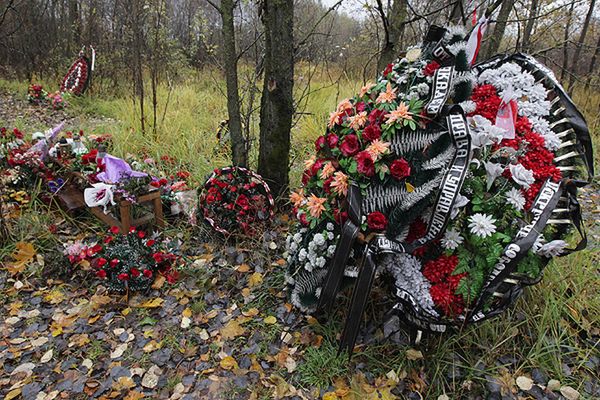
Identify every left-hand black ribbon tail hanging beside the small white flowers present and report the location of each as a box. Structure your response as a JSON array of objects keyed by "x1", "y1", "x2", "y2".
[{"x1": 317, "y1": 184, "x2": 362, "y2": 313}]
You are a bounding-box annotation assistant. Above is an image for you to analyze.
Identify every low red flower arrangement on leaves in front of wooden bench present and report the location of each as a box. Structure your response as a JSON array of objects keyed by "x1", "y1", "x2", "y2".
[{"x1": 64, "y1": 227, "x2": 181, "y2": 293}]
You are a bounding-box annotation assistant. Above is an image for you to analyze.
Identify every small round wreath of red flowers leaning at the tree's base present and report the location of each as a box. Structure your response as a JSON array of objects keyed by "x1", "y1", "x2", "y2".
[{"x1": 199, "y1": 167, "x2": 275, "y2": 235}]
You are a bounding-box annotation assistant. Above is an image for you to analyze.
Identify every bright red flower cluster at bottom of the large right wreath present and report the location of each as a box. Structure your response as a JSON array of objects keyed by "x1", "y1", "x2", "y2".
[{"x1": 423, "y1": 255, "x2": 466, "y2": 316}]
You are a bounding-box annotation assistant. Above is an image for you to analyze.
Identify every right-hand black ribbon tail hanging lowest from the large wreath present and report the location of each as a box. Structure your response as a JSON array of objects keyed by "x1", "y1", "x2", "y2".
[{"x1": 339, "y1": 245, "x2": 377, "y2": 356}]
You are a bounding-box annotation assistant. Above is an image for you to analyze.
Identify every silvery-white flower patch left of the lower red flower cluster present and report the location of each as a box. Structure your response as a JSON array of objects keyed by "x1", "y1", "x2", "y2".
[{"x1": 381, "y1": 254, "x2": 439, "y2": 317}]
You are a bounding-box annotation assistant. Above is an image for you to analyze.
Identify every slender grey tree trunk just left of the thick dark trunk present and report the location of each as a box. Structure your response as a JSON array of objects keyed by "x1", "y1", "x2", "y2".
[{"x1": 219, "y1": 0, "x2": 248, "y2": 167}]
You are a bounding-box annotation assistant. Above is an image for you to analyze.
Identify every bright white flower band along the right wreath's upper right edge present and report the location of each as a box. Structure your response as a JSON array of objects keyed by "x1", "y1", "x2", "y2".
[{"x1": 479, "y1": 63, "x2": 560, "y2": 151}]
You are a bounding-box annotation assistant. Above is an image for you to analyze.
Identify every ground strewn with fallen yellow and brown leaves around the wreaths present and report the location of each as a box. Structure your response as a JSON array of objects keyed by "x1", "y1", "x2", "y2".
[{"x1": 0, "y1": 91, "x2": 600, "y2": 400}]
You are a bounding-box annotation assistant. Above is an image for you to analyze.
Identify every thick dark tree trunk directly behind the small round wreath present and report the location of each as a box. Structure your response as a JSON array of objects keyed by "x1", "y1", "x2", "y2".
[{"x1": 258, "y1": 0, "x2": 294, "y2": 198}]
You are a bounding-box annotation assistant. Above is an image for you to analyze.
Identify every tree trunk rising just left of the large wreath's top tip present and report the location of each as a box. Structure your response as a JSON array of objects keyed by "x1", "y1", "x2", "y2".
[{"x1": 377, "y1": 0, "x2": 408, "y2": 73}]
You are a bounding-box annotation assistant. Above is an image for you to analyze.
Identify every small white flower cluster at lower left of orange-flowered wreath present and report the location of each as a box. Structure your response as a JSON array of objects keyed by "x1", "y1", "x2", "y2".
[{"x1": 286, "y1": 222, "x2": 337, "y2": 272}]
